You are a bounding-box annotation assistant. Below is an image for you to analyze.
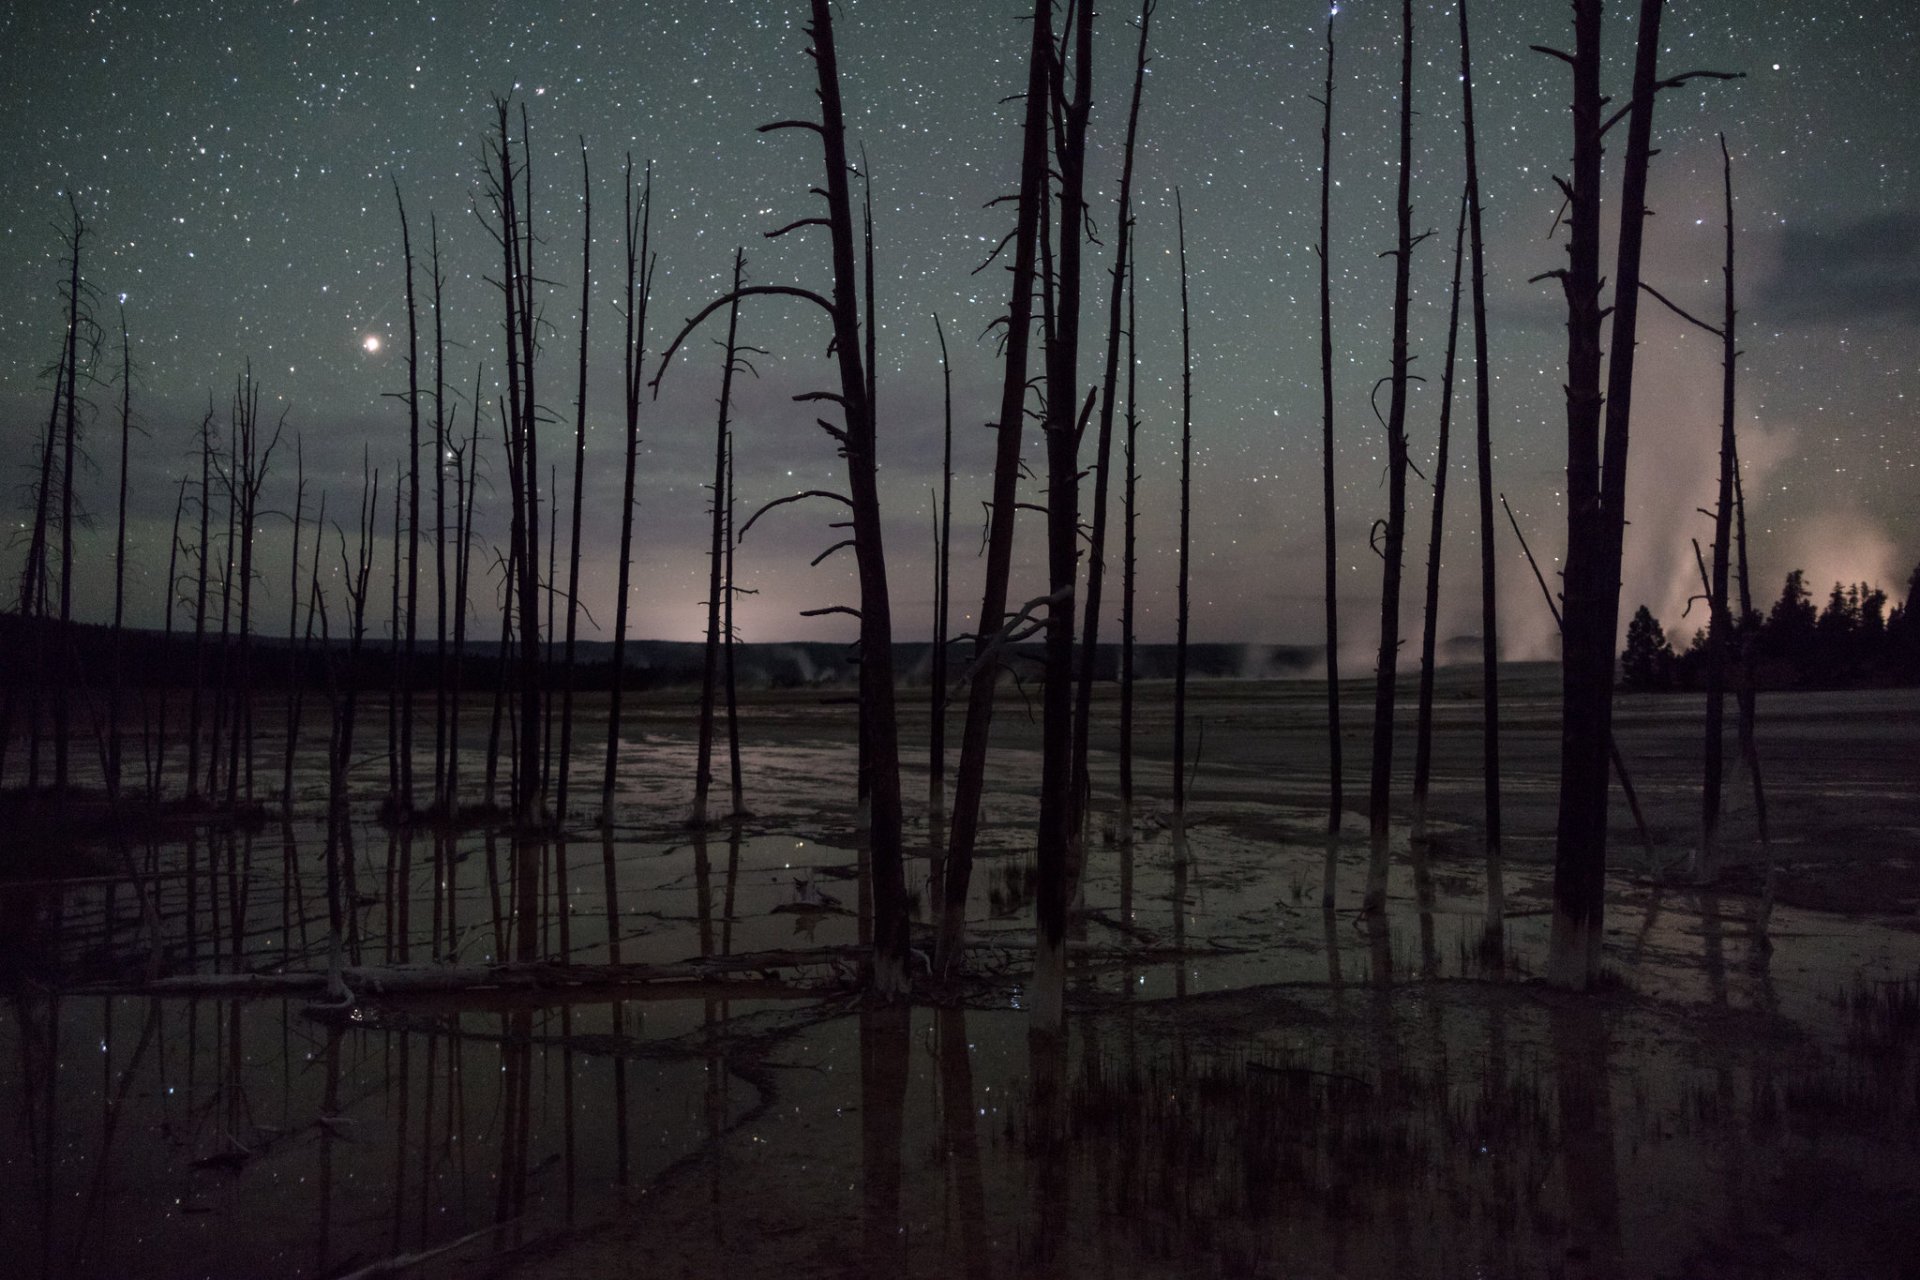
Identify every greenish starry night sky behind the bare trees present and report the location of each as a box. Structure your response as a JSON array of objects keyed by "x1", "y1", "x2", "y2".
[{"x1": 0, "y1": 0, "x2": 1920, "y2": 662}]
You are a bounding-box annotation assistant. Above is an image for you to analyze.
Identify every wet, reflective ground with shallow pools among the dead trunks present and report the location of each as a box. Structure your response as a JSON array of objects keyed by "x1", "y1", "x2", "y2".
[{"x1": 0, "y1": 670, "x2": 1920, "y2": 1276}]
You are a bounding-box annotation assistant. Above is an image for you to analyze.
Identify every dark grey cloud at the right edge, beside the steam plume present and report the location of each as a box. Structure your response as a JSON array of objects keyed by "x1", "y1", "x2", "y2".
[{"x1": 1755, "y1": 209, "x2": 1920, "y2": 324}]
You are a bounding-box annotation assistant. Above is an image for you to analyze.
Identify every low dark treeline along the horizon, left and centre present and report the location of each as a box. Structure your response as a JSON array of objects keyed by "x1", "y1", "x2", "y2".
[{"x1": 0, "y1": 614, "x2": 1321, "y2": 691}]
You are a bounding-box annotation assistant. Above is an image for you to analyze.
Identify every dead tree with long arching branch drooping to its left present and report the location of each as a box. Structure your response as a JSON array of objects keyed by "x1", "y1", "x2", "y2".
[{"x1": 653, "y1": 0, "x2": 908, "y2": 994}]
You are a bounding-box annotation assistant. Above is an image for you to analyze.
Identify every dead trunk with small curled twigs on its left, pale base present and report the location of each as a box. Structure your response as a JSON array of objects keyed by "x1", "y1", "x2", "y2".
[{"x1": 1361, "y1": 0, "x2": 1425, "y2": 915}]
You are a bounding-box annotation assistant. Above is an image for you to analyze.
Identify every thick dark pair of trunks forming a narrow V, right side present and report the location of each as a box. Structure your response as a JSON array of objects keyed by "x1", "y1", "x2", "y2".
[{"x1": 1542, "y1": 0, "x2": 1724, "y2": 988}]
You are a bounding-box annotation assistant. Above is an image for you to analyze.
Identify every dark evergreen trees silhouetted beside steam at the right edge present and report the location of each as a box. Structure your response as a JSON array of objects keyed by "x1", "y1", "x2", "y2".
[{"x1": 1620, "y1": 566, "x2": 1920, "y2": 689}]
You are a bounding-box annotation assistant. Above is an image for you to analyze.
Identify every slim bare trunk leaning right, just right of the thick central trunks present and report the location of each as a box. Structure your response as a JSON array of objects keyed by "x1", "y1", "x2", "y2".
[{"x1": 1073, "y1": 0, "x2": 1156, "y2": 881}]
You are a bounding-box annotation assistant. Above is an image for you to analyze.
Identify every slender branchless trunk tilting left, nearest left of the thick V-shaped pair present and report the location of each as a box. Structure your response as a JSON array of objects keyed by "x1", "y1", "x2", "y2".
[{"x1": 1459, "y1": 0, "x2": 1507, "y2": 946}]
